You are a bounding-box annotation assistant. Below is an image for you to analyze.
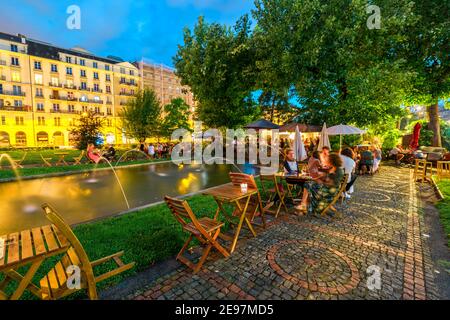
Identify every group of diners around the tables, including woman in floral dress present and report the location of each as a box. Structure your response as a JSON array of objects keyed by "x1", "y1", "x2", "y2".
[{"x1": 283, "y1": 146, "x2": 381, "y2": 215}]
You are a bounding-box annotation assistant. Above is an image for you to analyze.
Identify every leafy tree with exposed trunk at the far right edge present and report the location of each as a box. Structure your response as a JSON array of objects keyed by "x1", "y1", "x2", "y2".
[{"x1": 395, "y1": 0, "x2": 450, "y2": 146}]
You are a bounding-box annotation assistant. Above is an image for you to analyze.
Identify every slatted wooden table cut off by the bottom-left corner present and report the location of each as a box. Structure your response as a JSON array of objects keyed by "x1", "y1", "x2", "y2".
[{"x1": 0, "y1": 225, "x2": 70, "y2": 300}]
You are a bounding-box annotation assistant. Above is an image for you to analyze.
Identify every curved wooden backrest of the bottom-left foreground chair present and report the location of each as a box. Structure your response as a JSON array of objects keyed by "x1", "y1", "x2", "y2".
[{"x1": 42, "y1": 203, "x2": 93, "y2": 275}]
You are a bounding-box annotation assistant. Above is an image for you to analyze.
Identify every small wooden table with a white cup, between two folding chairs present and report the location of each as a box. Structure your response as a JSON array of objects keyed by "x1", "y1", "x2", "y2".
[{"x1": 203, "y1": 183, "x2": 266, "y2": 253}]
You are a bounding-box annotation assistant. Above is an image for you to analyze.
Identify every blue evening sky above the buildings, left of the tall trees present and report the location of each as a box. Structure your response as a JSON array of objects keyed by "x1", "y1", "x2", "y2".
[{"x1": 0, "y1": 0, "x2": 253, "y2": 66}]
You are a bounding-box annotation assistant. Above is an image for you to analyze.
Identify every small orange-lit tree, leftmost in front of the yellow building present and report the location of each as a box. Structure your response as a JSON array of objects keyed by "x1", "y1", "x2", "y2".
[{"x1": 70, "y1": 111, "x2": 104, "y2": 150}]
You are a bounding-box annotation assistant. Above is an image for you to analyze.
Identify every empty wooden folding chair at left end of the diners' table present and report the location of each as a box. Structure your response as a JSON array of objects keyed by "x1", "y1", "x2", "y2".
[{"x1": 259, "y1": 174, "x2": 289, "y2": 218}]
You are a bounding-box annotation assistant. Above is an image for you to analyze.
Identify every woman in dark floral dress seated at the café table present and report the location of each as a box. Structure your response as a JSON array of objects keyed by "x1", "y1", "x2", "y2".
[{"x1": 296, "y1": 153, "x2": 344, "y2": 215}]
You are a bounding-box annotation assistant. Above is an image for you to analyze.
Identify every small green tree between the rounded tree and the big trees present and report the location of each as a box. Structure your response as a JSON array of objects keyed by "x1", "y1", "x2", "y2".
[{"x1": 161, "y1": 98, "x2": 190, "y2": 137}]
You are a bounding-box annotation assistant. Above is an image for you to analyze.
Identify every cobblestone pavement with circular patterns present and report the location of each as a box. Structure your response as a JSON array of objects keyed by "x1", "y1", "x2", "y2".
[{"x1": 127, "y1": 166, "x2": 439, "y2": 300}]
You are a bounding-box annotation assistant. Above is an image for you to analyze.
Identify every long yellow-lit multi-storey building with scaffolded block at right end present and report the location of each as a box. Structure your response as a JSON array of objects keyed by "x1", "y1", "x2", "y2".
[{"x1": 0, "y1": 32, "x2": 194, "y2": 148}]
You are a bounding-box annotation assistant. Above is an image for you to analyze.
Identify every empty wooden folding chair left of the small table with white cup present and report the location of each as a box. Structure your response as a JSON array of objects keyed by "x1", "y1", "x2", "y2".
[{"x1": 164, "y1": 196, "x2": 230, "y2": 273}]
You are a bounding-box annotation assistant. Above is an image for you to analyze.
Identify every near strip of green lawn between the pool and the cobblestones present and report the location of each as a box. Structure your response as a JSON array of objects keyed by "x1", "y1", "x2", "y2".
[{"x1": 0, "y1": 195, "x2": 236, "y2": 299}]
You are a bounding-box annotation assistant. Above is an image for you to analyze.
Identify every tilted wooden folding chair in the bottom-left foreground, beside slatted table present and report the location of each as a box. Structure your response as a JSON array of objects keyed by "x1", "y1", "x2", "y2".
[{"x1": 40, "y1": 204, "x2": 134, "y2": 300}]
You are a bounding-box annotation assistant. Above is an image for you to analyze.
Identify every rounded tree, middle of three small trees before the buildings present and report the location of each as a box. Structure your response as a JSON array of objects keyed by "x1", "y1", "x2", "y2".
[{"x1": 120, "y1": 89, "x2": 161, "y2": 140}]
